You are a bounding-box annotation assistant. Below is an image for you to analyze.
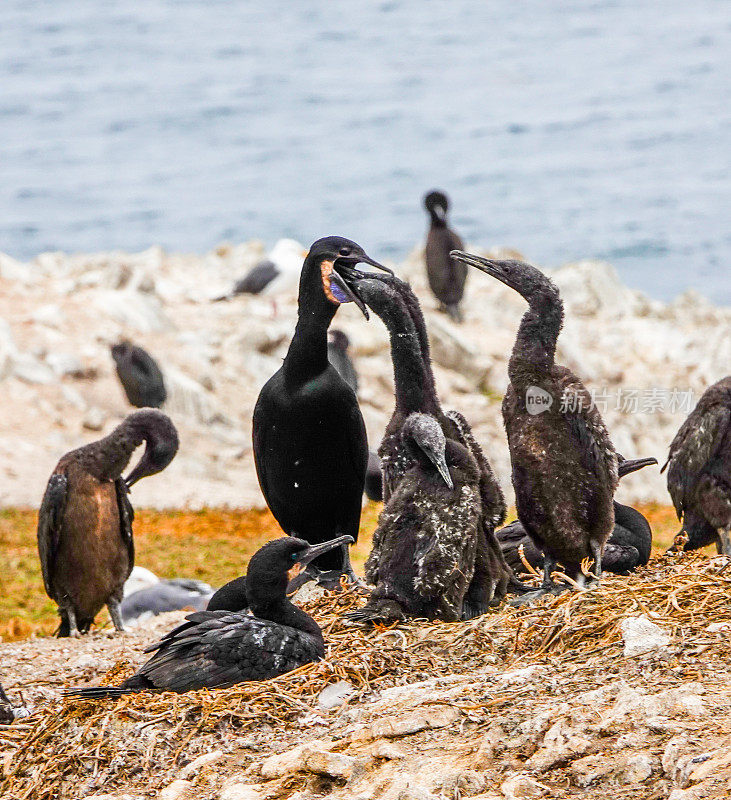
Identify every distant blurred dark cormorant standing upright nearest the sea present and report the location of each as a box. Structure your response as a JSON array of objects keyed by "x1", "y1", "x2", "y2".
[{"x1": 424, "y1": 192, "x2": 467, "y2": 322}]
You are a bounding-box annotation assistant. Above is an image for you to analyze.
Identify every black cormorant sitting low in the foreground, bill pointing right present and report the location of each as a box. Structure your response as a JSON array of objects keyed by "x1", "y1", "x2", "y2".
[{"x1": 65, "y1": 536, "x2": 352, "y2": 698}]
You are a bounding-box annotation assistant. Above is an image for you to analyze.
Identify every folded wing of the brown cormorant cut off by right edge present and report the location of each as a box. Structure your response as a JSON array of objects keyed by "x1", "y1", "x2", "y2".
[{"x1": 663, "y1": 405, "x2": 731, "y2": 519}]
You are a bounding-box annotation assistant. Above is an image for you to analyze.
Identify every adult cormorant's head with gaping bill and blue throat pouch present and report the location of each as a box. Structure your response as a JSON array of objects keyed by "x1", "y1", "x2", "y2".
[{"x1": 300, "y1": 236, "x2": 393, "y2": 319}]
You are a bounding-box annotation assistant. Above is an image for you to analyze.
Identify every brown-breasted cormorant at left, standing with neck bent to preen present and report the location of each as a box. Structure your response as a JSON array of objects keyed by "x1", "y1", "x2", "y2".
[{"x1": 38, "y1": 409, "x2": 178, "y2": 636}]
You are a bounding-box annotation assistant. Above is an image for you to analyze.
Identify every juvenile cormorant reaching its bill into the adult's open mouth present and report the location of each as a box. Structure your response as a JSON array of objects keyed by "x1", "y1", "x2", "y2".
[{"x1": 358, "y1": 277, "x2": 517, "y2": 617}]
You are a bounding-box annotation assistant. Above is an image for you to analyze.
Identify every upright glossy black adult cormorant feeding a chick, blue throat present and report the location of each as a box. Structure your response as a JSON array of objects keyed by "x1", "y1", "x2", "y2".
[{"x1": 253, "y1": 236, "x2": 390, "y2": 581}]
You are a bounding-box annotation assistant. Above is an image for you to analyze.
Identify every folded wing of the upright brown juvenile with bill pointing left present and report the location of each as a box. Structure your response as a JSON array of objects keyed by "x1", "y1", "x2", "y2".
[{"x1": 554, "y1": 366, "x2": 619, "y2": 489}]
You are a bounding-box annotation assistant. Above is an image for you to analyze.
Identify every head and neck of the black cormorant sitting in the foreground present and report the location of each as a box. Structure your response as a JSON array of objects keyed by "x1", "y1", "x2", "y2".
[{"x1": 246, "y1": 536, "x2": 353, "y2": 606}]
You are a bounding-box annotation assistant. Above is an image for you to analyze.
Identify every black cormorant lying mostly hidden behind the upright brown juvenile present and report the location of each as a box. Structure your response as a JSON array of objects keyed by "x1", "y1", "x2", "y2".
[{"x1": 495, "y1": 458, "x2": 657, "y2": 575}]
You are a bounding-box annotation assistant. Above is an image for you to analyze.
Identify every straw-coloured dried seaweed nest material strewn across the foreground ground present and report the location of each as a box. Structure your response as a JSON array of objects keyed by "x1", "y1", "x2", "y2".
[{"x1": 5, "y1": 553, "x2": 731, "y2": 800}]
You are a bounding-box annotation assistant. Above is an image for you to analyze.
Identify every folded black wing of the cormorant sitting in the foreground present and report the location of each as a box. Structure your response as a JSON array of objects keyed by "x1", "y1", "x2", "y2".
[{"x1": 138, "y1": 611, "x2": 319, "y2": 692}]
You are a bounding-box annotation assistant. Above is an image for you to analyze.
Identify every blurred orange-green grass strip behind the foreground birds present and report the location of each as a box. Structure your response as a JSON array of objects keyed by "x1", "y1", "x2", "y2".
[{"x1": 0, "y1": 503, "x2": 692, "y2": 642}]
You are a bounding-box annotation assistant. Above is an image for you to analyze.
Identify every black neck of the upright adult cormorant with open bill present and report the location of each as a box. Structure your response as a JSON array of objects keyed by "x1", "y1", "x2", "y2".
[{"x1": 284, "y1": 259, "x2": 338, "y2": 384}]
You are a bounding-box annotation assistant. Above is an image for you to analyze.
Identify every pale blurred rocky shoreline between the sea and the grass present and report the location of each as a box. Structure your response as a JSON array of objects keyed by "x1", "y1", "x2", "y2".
[{"x1": 0, "y1": 241, "x2": 731, "y2": 508}]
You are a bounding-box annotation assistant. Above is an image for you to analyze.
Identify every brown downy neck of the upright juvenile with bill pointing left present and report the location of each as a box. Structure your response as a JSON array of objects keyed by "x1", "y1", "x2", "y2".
[{"x1": 508, "y1": 286, "x2": 563, "y2": 393}]
